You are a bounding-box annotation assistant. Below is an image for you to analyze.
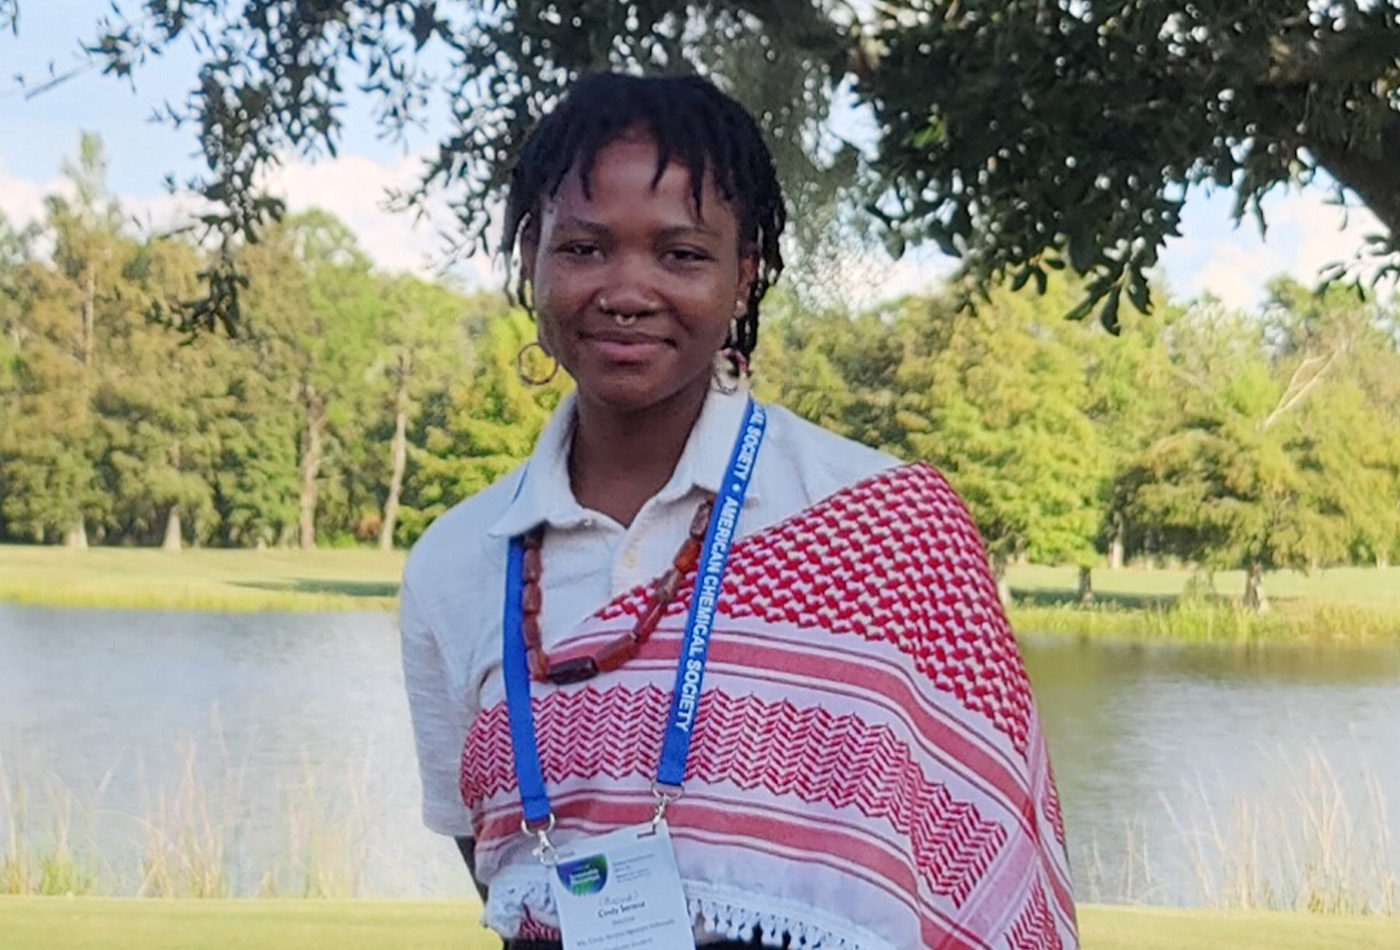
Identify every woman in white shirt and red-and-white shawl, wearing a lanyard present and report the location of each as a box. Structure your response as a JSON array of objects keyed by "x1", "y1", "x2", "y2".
[{"x1": 402, "y1": 76, "x2": 1077, "y2": 950}]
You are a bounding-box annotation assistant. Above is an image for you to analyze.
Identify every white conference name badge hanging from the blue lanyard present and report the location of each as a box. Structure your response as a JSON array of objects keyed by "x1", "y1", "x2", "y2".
[{"x1": 547, "y1": 821, "x2": 696, "y2": 950}]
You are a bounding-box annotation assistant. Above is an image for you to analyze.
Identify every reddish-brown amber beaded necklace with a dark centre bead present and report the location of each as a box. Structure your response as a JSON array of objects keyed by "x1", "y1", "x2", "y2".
[{"x1": 521, "y1": 495, "x2": 714, "y2": 686}]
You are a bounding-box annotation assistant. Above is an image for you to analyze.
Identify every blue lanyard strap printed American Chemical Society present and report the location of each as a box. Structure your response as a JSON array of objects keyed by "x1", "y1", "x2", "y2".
[{"x1": 503, "y1": 399, "x2": 767, "y2": 825}]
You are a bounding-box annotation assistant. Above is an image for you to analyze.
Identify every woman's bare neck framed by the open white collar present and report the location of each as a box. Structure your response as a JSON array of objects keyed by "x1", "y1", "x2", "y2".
[{"x1": 568, "y1": 378, "x2": 710, "y2": 525}]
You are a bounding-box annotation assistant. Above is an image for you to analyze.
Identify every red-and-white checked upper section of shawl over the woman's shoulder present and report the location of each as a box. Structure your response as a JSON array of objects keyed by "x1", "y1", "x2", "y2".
[{"x1": 596, "y1": 465, "x2": 1030, "y2": 754}]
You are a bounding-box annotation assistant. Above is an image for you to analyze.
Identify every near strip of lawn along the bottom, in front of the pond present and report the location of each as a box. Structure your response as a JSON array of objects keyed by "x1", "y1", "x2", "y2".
[{"x1": 0, "y1": 897, "x2": 1400, "y2": 950}]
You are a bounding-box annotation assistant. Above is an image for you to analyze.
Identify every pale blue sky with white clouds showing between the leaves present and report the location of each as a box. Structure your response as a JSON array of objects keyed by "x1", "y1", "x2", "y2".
[{"x1": 0, "y1": 0, "x2": 1380, "y2": 309}]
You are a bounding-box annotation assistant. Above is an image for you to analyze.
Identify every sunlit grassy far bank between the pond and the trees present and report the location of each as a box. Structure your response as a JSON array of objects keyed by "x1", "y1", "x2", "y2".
[{"x1": 0, "y1": 546, "x2": 1400, "y2": 645}]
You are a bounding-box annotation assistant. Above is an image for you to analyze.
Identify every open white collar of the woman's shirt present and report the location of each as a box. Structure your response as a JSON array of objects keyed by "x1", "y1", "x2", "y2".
[{"x1": 487, "y1": 385, "x2": 759, "y2": 537}]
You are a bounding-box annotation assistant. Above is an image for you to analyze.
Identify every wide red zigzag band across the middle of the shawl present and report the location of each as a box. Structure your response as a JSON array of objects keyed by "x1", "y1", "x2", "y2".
[{"x1": 462, "y1": 686, "x2": 1007, "y2": 905}]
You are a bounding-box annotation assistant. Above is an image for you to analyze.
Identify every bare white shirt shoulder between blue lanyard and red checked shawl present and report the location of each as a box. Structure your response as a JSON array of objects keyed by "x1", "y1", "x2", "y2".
[{"x1": 759, "y1": 404, "x2": 900, "y2": 501}]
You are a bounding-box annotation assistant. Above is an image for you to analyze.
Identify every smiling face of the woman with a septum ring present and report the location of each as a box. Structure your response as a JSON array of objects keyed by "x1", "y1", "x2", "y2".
[{"x1": 522, "y1": 130, "x2": 757, "y2": 411}]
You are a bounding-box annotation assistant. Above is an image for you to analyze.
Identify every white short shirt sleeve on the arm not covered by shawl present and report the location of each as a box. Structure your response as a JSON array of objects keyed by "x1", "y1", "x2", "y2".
[{"x1": 399, "y1": 578, "x2": 473, "y2": 838}]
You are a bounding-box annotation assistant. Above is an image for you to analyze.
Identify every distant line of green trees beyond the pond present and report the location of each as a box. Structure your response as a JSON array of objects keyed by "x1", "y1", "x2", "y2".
[{"x1": 0, "y1": 140, "x2": 1400, "y2": 604}]
